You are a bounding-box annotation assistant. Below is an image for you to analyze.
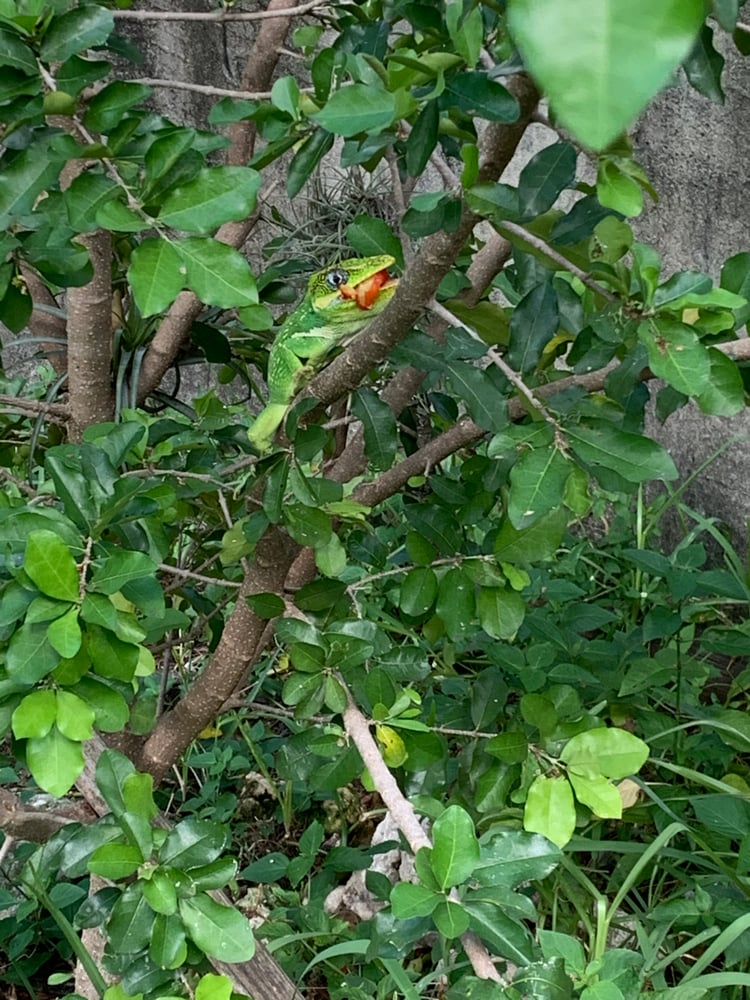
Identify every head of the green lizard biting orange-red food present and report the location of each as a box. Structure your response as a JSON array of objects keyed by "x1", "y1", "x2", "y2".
[{"x1": 308, "y1": 254, "x2": 398, "y2": 326}]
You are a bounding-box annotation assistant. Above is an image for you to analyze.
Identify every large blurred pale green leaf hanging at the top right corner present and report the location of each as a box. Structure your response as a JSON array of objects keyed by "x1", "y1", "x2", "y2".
[{"x1": 508, "y1": 0, "x2": 705, "y2": 149}]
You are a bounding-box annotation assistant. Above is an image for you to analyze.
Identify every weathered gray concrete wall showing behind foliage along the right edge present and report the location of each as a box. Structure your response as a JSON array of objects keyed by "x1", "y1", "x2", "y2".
[{"x1": 635, "y1": 39, "x2": 750, "y2": 554}]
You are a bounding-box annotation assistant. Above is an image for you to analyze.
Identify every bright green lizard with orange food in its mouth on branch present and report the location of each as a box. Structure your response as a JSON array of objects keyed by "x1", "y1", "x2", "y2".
[{"x1": 248, "y1": 255, "x2": 398, "y2": 453}]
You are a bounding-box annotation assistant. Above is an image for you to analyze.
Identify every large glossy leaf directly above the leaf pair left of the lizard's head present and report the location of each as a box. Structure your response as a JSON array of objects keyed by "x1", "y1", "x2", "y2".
[{"x1": 159, "y1": 167, "x2": 261, "y2": 233}]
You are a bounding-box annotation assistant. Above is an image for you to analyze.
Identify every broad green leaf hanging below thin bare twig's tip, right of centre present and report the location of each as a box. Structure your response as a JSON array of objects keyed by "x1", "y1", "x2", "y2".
[{"x1": 507, "y1": 446, "x2": 573, "y2": 529}]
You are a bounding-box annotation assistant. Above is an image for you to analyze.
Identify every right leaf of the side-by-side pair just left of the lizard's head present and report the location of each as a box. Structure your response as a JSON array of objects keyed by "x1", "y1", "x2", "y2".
[{"x1": 177, "y1": 236, "x2": 258, "y2": 309}]
